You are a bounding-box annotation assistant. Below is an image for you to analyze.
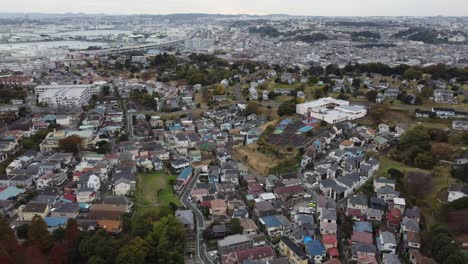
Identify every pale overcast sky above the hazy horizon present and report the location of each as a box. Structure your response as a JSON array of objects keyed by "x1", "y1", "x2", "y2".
[{"x1": 0, "y1": 0, "x2": 468, "y2": 16}]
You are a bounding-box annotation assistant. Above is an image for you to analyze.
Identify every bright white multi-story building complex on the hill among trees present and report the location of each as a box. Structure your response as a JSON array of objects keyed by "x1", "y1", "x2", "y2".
[{"x1": 296, "y1": 97, "x2": 367, "y2": 124}]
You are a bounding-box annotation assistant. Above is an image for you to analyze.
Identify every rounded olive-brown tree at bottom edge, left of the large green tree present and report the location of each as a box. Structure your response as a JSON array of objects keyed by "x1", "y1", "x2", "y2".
[{"x1": 115, "y1": 236, "x2": 150, "y2": 264}]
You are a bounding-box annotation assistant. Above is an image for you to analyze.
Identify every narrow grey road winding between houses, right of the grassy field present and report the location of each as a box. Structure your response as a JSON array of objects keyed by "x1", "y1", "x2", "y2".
[{"x1": 180, "y1": 170, "x2": 214, "y2": 264}]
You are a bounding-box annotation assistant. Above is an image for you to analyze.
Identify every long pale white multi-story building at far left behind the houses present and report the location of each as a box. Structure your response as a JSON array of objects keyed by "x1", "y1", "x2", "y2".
[{"x1": 34, "y1": 84, "x2": 100, "y2": 107}]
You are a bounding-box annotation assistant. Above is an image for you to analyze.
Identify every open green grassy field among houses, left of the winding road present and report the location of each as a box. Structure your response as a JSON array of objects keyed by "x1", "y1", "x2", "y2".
[{"x1": 135, "y1": 173, "x2": 180, "y2": 214}]
